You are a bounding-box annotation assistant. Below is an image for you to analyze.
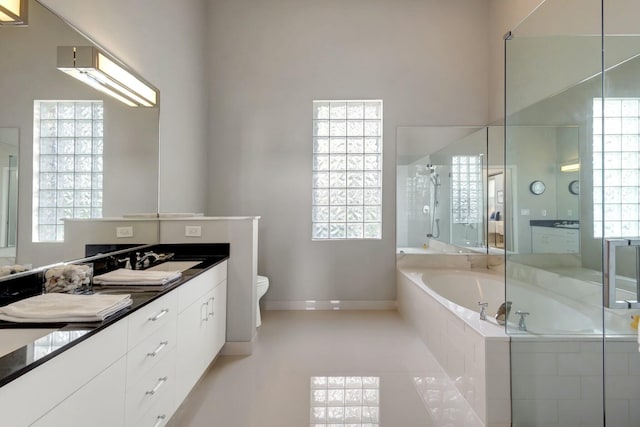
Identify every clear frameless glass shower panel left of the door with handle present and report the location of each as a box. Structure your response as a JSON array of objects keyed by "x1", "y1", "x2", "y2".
[{"x1": 504, "y1": 0, "x2": 605, "y2": 427}]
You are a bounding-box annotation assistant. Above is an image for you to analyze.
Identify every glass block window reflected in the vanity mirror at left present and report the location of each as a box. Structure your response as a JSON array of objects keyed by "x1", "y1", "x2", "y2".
[{"x1": 32, "y1": 101, "x2": 103, "y2": 242}]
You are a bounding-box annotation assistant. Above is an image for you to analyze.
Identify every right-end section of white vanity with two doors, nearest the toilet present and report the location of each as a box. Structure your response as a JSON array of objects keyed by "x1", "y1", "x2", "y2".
[{"x1": 176, "y1": 261, "x2": 227, "y2": 402}]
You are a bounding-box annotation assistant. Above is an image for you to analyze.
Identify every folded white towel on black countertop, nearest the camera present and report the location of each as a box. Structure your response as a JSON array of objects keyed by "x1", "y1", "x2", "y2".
[{"x1": 0, "y1": 293, "x2": 132, "y2": 323}]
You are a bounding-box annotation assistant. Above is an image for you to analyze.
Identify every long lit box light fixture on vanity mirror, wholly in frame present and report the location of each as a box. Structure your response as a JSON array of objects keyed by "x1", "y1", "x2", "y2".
[{"x1": 58, "y1": 46, "x2": 158, "y2": 107}]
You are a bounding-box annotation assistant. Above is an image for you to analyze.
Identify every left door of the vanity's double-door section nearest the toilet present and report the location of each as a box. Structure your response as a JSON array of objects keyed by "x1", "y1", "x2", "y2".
[{"x1": 176, "y1": 291, "x2": 213, "y2": 402}]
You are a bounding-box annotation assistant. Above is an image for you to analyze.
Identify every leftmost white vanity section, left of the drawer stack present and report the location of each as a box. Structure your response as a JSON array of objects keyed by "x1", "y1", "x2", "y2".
[{"x1": 0, "y1": 318, "x2": 128, "y2": 427}]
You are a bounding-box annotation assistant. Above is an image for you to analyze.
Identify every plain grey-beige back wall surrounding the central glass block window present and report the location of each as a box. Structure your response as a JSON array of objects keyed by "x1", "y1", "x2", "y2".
[{"x1": 207, "y1": 0, "x2": 489, "y2": 301}]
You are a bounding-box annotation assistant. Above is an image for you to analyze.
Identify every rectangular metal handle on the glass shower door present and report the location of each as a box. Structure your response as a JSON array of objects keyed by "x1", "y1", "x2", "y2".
[{"x1": 603, "y1": 239, "x2": 640, "y2": 309}]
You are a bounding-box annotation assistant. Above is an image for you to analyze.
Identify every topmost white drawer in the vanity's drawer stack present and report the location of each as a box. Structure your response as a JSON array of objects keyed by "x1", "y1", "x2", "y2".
[{"x1": 128, "y1": 292, "x2": 177, "y2": 349}]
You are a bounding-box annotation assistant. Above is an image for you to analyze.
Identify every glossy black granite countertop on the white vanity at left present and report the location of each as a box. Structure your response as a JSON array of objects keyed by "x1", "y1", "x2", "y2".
[{"x1": 0, "y1": 244, "x2": 229, "y2": 387}]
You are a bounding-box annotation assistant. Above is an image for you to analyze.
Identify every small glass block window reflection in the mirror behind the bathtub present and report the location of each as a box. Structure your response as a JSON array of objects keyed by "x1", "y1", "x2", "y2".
[{"x1": 451, "y1": 156, "x2": 482, "y2": 224}]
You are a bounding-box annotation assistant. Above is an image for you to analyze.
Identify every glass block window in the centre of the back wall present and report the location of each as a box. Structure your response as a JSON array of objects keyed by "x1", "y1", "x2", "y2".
[{"x1": 311, "y1": 100, "x2": 382, "y2": 240}]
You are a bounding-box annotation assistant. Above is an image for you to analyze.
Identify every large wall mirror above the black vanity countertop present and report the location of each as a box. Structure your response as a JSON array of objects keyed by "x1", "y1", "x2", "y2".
[{"x1": 0, "y1": 0, "x2": 159, "y2": 267}]
